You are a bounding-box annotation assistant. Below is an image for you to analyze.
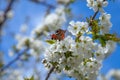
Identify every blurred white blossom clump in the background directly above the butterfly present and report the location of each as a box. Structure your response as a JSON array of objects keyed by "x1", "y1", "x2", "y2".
[{"x1": 44, "y1": 7, "x2": 66, "y2": 31}]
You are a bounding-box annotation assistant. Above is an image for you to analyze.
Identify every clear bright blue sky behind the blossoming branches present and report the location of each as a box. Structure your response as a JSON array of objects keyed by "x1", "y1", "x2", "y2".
[{"x1": 0, "y1": 0, "x2": 120, "y2": 79}]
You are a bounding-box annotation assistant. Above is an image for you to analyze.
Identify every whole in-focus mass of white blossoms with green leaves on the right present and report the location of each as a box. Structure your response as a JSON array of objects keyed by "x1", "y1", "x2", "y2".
[{"x1": 43, "y1": 0, "x2": 115, "y2": 80}]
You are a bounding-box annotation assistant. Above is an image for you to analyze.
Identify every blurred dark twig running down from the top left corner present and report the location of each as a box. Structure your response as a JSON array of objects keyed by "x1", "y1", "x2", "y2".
[{"x1": 0, "y1": 0, "x2": 15, "y2": 32}]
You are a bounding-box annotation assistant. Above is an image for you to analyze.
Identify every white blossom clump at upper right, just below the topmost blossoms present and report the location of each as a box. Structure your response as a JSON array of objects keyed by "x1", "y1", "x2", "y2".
[{"x1": 99, "y1": 13, "x2": 112, "y2": 33}]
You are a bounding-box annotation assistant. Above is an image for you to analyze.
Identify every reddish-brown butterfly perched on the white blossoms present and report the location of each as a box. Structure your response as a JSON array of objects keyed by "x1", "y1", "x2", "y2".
[{"x1": 51, "y1": 29, "x2": 66, "y2": 41}]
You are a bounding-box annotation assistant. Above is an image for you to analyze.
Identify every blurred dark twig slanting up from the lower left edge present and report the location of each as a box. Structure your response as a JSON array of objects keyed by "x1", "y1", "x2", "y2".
[{"x1": 0, "y1": 48, "x2": 28, "y2": 73}]
